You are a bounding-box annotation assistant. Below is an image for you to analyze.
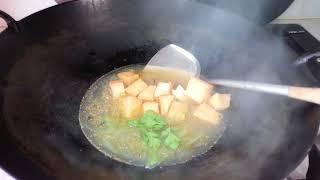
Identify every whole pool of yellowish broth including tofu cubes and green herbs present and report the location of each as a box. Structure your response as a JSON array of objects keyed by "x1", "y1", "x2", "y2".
[{"x1": 79, "y1": 65, "x2": 230, "y2": 168}]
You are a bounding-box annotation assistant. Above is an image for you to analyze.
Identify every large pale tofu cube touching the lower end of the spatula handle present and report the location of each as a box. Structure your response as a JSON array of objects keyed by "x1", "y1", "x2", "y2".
[{"x1": 186, "y1": 78, "x2": 213, "y2": 104}]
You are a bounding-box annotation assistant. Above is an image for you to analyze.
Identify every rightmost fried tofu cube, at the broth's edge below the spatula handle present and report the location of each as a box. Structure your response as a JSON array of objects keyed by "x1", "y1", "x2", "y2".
[{"x1": 209, "y1": 93, "x2": 231, "y2": 111}]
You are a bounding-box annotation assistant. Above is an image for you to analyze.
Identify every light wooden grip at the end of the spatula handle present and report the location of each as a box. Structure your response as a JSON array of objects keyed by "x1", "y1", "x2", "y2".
[{"x1": 288, "y1": 86, "x2": 320, "y2": 105}]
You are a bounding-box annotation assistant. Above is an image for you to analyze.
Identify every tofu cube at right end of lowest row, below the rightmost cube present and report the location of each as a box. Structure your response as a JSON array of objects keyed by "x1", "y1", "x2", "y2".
[{"x1": 193, "y1": 103, "x2": 222, "y2": 125}]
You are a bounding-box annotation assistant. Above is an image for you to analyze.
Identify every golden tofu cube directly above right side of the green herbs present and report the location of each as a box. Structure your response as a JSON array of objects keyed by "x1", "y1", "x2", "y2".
[{"x1": 168, "y1": 101, "x2": 188, "y2": 125}]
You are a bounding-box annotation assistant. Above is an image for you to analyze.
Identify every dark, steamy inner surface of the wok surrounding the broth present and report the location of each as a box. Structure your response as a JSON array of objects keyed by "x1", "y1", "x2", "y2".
[{"x1": 0, "y1": 0, "x2": 319, "y2": 180}]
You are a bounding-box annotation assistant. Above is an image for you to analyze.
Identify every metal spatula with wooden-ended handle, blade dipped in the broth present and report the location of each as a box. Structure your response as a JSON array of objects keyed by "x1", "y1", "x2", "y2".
[{"x1": 146, "y1": 44, "x2": 320, "y2": 105}]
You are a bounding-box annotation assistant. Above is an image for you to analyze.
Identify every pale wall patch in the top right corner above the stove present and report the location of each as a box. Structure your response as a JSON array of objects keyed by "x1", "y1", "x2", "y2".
[{"x1": 278, "y1": 0, "x2": 320, "y2": 19}]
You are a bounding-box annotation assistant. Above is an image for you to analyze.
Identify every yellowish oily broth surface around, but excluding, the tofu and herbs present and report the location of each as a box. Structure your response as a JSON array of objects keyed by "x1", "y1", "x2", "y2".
[{"x1": 79, "y1": 65, "x2": 225, "y2": 168}]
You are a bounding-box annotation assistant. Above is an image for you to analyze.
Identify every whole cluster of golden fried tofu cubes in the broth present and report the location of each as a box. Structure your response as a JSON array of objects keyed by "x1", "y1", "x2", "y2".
[{"x1": 109, "y1": 71, "x2": 231, "y2": 125}]
